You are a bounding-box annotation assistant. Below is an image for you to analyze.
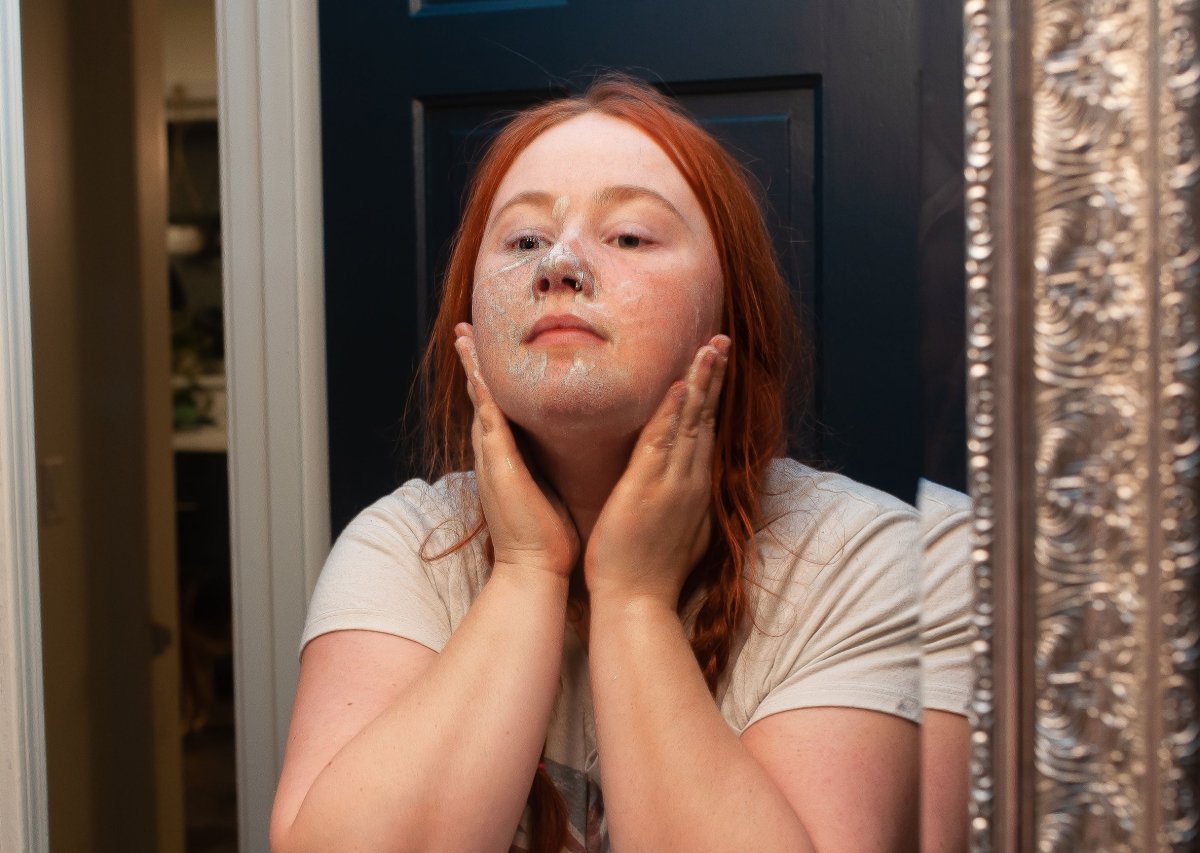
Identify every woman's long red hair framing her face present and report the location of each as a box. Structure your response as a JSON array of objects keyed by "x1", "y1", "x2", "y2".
[{"x1": 421, "y1": 76, "x2": 806, "y2": 852}]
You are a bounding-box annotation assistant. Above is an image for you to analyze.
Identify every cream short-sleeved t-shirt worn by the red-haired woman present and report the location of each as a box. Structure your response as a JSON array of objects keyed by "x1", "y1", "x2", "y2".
[{"x1": 302, "y1": 459, "x2": 920, "y2": 851}]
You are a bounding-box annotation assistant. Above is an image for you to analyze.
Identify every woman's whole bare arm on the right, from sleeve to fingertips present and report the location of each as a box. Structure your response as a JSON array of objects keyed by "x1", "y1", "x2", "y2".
[{"x1": 586, "y1": 341, "x2": 918, "y2": 851}]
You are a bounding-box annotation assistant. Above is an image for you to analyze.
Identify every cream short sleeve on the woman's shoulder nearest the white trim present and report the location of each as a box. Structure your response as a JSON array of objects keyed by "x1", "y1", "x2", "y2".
[{"x1": 301, "y1": 481, "x2": 472, "y2": 651}]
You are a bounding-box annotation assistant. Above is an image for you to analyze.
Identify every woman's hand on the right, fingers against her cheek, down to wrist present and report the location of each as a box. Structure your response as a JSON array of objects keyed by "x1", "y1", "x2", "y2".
[{"x1": 583, "y1": 335, "x2": 730, "y2": 609}]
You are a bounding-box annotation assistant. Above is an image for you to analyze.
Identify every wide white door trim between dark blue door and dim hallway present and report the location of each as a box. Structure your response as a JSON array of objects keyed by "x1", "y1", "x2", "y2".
[{"x1": 216, "y1": 0, "x2": 330, "y2": 853}]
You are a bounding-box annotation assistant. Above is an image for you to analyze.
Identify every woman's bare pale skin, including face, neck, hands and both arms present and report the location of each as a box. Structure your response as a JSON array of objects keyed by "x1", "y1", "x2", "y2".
[{"x1": 271, "y1": 115, "x2": 918, "y2": 852}]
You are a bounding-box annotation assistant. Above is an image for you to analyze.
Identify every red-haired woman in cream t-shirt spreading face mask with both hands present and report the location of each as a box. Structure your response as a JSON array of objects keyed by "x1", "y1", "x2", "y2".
[{"x1": 271, "y1": 79, "x2": 919, "y2": 852}]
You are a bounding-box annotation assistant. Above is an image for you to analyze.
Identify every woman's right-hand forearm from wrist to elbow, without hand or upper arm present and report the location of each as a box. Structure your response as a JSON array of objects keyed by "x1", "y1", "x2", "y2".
[{"x1": 589, "y1": 597, "x2": 811, "y2": 852}]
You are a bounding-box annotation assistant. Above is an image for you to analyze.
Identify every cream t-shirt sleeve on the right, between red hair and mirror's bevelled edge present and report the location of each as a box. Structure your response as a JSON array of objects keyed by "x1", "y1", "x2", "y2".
[{"x1": 720, "y1": 463, "x2": 920, "y2": 731}]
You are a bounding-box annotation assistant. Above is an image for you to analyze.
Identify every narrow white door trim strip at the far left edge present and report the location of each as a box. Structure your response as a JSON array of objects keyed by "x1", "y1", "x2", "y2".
[{"x1": 0, "y1": 0, "x2": 49, "y2": 853}]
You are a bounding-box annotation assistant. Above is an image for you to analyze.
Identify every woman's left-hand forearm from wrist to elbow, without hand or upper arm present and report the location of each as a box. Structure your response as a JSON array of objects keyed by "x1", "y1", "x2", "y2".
[{"x1": 274, "y1": 569, "x2": 566, "y2": 852}]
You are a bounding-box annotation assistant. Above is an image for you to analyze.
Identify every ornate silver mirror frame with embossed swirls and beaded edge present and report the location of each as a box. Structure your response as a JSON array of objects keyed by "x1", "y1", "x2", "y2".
[{"x1": 964, "y1": 0, "x2": 1200, "y2": 851}]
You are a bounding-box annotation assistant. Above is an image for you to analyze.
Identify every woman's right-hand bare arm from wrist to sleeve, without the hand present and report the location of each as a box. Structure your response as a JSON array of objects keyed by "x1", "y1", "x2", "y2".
[{"x1": 590, "y1": 605, "x2": 919, "y2": 853}]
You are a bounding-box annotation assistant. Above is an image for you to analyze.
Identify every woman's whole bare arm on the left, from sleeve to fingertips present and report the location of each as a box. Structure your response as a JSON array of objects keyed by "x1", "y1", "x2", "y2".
[{"x1": 271, "y1": 328, "x2": 578, "y2": 853}]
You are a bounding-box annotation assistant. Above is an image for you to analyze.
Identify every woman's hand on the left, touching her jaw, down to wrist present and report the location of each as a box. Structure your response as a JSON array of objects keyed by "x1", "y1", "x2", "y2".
[{"x1": 455, "y1": 323, "x2": 580, "y2": 577}]
